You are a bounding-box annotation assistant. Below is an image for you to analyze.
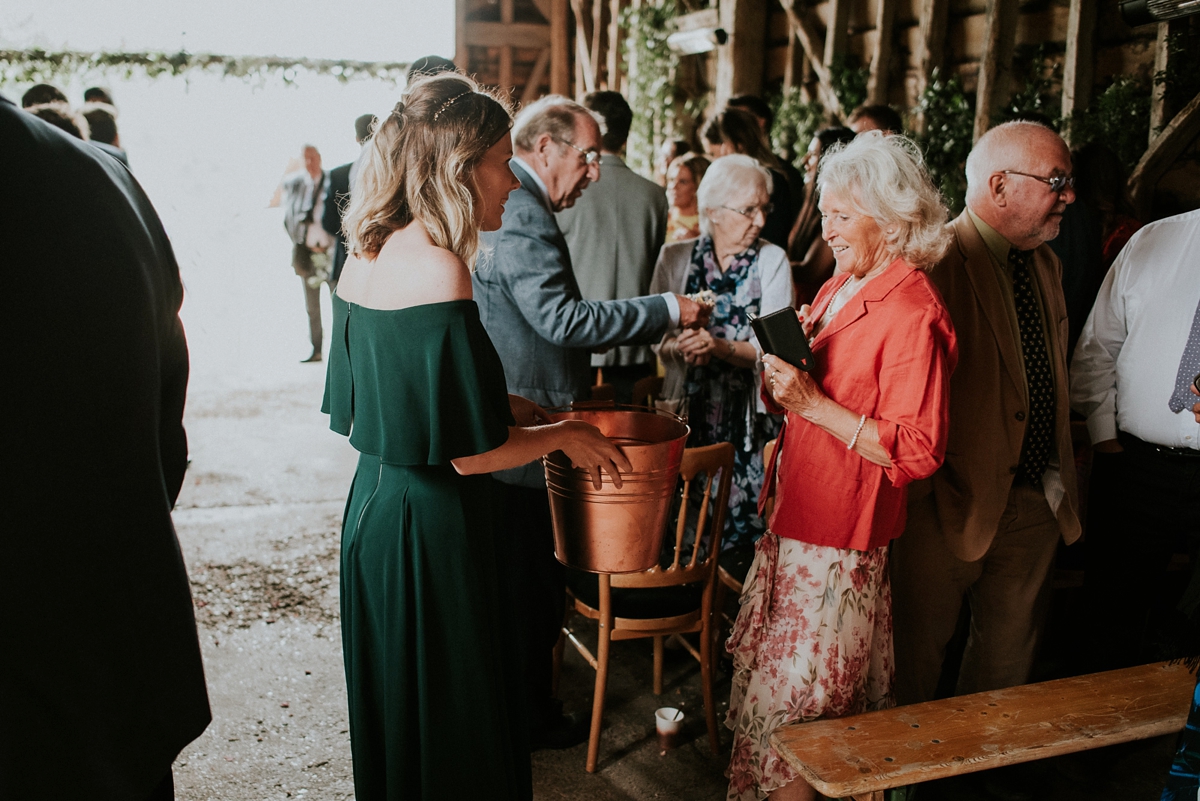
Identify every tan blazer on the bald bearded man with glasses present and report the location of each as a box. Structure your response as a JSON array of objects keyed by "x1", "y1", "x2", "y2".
[{"x1": 908, "y1": 211, "x2": 1080, "y2": 561}]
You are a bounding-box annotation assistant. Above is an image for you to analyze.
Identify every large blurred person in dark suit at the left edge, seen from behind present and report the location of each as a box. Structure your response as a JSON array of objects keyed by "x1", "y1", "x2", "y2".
[{"x1": 0, "y1": 97, "x2": 211, "y2": 801}]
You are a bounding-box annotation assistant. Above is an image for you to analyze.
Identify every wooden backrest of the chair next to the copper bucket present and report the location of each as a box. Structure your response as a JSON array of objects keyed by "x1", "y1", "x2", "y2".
[{"x1": 612, "y1": 442, "x2": 733, "y2": 588}]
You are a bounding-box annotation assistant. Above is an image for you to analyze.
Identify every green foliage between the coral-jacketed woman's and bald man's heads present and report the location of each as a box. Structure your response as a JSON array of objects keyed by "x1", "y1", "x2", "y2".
[{"x1": 914, "y1": 70, "x2": 974, "y2": 213}]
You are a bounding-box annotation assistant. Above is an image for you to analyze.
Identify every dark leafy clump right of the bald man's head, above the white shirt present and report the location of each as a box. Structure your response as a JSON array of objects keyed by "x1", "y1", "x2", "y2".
[{"x1": 1067, "y1": 76, "x2": 1150, "y2": 169}]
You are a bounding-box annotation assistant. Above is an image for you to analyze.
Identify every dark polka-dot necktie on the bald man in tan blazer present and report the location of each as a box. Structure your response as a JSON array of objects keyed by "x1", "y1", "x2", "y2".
[{"x1": 1008, "y1": 247, "x2": 1055, "y2": 487}]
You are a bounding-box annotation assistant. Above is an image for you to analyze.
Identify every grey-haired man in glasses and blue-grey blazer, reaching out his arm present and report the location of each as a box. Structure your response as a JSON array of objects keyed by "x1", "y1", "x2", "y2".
[{"x1": 474, "y1": 96, "x2": 708, "y2": 748}]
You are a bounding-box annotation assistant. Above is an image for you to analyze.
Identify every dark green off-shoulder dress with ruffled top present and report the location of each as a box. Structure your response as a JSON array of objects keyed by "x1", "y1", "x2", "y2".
[{"x1": 324, "y1": 296, "x2": 533, "y2": 801}]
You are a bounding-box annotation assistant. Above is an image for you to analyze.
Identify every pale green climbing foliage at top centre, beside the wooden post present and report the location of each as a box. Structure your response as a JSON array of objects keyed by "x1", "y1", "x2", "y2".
[{"x1": 620, "y1": 0, "x2": 678, "y2": 175}]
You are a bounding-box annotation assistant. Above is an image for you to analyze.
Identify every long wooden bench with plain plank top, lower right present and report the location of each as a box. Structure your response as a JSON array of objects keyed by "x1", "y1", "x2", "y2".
[{"x1": 770, "y1": 662, "x2": 1196, "y2": 801}]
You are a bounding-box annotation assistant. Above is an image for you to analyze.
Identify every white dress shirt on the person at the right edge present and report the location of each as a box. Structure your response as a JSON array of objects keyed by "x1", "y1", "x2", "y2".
[{"x1": 1070, "y1": 211, "x2": 1200, "y2": 448}]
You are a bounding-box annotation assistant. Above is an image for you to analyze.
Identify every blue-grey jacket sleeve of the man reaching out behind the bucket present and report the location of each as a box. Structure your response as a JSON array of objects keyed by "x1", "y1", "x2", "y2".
[{"x1": 497, "y1": 200, "x2": 671, "y2": 348}]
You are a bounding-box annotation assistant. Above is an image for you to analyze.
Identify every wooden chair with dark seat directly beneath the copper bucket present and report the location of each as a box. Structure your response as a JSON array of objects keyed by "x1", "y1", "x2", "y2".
[{"x1": 554, "y1": 442, "x2": 733, "y2": 773}]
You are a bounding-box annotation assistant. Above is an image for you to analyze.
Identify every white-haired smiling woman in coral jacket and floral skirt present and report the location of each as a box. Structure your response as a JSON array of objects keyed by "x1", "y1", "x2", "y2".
[{"x1": 727, "y1": 133, "x2": 958, "y2": 801}]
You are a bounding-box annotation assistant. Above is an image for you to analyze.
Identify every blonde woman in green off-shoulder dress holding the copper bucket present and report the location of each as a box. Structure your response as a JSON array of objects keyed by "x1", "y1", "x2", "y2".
[{"x1": 324, "y1": 74, "x2": 630, "y2": 801}]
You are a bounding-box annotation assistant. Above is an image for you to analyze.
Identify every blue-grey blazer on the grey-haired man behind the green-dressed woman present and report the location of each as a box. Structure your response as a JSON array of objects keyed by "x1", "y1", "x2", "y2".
[{"x1": 473, "y1": 164, "x2": 671, "y2": 487}]
